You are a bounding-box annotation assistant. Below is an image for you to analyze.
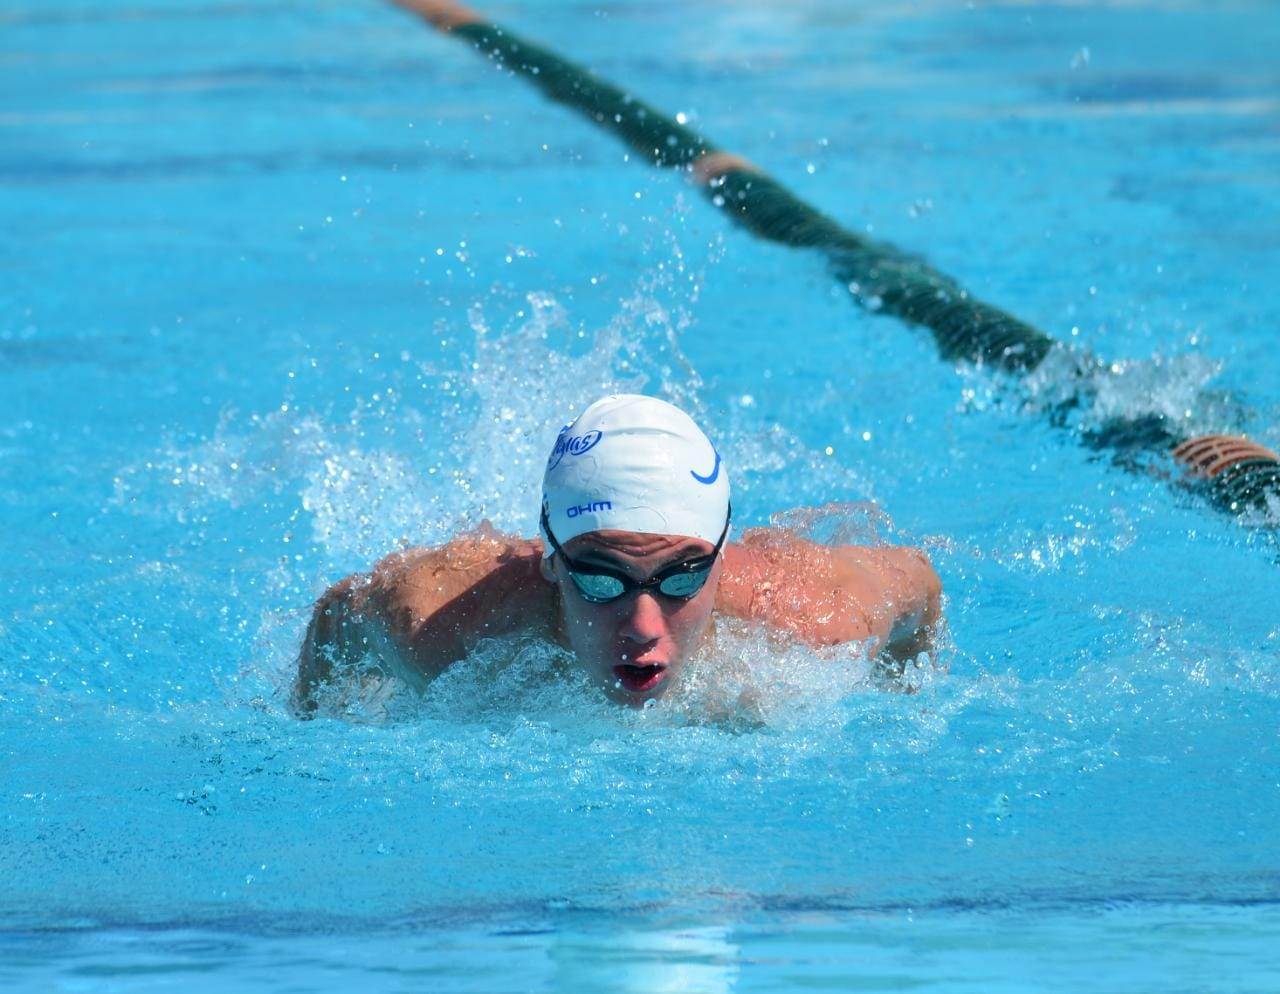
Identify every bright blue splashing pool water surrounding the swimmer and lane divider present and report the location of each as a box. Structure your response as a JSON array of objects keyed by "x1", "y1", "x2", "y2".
[{"x1": 0, "y1": 0, "x2": 1280, "y2": 991}]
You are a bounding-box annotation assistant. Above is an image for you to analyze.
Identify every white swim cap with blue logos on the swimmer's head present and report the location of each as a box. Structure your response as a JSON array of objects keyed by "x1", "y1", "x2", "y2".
[{"x1": 543, "y1": 394, "x2": 728, "y2": 556}]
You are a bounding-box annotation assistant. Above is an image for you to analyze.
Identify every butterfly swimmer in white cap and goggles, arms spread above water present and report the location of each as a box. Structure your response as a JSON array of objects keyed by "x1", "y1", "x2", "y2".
[{"x1": 293, "y1": 394, "x2": 941, "y2": 715}]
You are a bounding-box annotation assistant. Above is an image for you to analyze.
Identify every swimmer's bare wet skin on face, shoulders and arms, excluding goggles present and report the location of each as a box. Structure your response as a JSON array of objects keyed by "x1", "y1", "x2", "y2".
[{"x1": 293, "y1": 527, "x2": 941, "y2": 716}]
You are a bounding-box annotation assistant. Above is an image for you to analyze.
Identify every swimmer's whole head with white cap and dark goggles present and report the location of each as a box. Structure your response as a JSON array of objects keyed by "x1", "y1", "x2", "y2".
[{"x1": 540, "y1": 394, "x2": 730, "y2": 704}]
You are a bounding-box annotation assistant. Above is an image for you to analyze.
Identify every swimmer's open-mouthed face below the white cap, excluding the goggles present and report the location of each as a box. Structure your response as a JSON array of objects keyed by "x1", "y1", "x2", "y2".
[{"x1": 543, "y1": 531, "x2": 723, "y2": 705}]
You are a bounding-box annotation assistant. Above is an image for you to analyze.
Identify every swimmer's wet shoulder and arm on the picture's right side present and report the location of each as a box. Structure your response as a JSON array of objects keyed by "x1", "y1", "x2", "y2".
[{"x1": 717, "y1": 528, "x2": 942, "y2": 660}]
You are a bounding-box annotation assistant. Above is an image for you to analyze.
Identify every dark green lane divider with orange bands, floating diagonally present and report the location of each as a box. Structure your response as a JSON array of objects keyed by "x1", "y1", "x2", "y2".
[{"x1": 393, "y1": 0, "x2": 1280, "y2": 527}]
